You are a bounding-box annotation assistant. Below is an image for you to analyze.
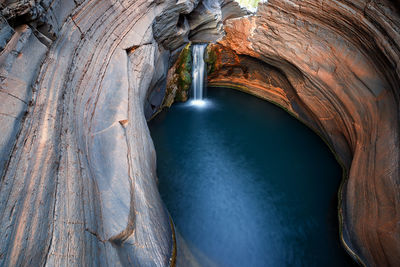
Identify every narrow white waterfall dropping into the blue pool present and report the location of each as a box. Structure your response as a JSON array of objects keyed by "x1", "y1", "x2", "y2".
[{"x1": 191, "y1": 44, "x2": 207, "y2": 105}]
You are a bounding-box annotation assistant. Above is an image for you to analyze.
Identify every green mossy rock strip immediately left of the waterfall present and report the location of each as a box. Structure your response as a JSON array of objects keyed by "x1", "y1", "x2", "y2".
[{"x1": 175, "y1": 43, "x2": 192, "y2": 102}]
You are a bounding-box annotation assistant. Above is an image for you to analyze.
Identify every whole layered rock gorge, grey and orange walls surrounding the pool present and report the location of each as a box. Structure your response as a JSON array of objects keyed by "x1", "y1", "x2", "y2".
[{"x1": 0, "y1": 0, "x2": 400, "y2": 266}]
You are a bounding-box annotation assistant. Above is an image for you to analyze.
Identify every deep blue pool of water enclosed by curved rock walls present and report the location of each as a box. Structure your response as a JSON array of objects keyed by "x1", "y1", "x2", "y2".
[{"x1": 149, "y1": 88, "x2": 353, "y2": 266}]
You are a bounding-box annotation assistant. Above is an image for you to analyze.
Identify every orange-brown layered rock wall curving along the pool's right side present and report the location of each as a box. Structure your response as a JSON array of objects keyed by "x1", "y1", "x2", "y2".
[{"x1": 208, "y1": 0, "x2": 400, "y2": 266}]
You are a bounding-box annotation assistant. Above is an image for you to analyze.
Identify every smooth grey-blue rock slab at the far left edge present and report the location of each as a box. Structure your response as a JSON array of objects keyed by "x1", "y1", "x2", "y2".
[{"x1": 0, "y1": 25, "x2": 47, "y2": 180}]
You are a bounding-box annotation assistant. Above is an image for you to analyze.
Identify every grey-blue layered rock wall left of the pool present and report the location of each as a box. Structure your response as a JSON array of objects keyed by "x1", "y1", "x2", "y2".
[{"x1": 0, "y1": 0, "x2": 205, "y2": 266}]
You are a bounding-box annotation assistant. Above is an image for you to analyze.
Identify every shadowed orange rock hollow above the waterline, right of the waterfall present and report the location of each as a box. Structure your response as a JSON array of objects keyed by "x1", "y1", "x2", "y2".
[{"x1": 206, "y1": 44, "x2": 314, "y2": 125}]
